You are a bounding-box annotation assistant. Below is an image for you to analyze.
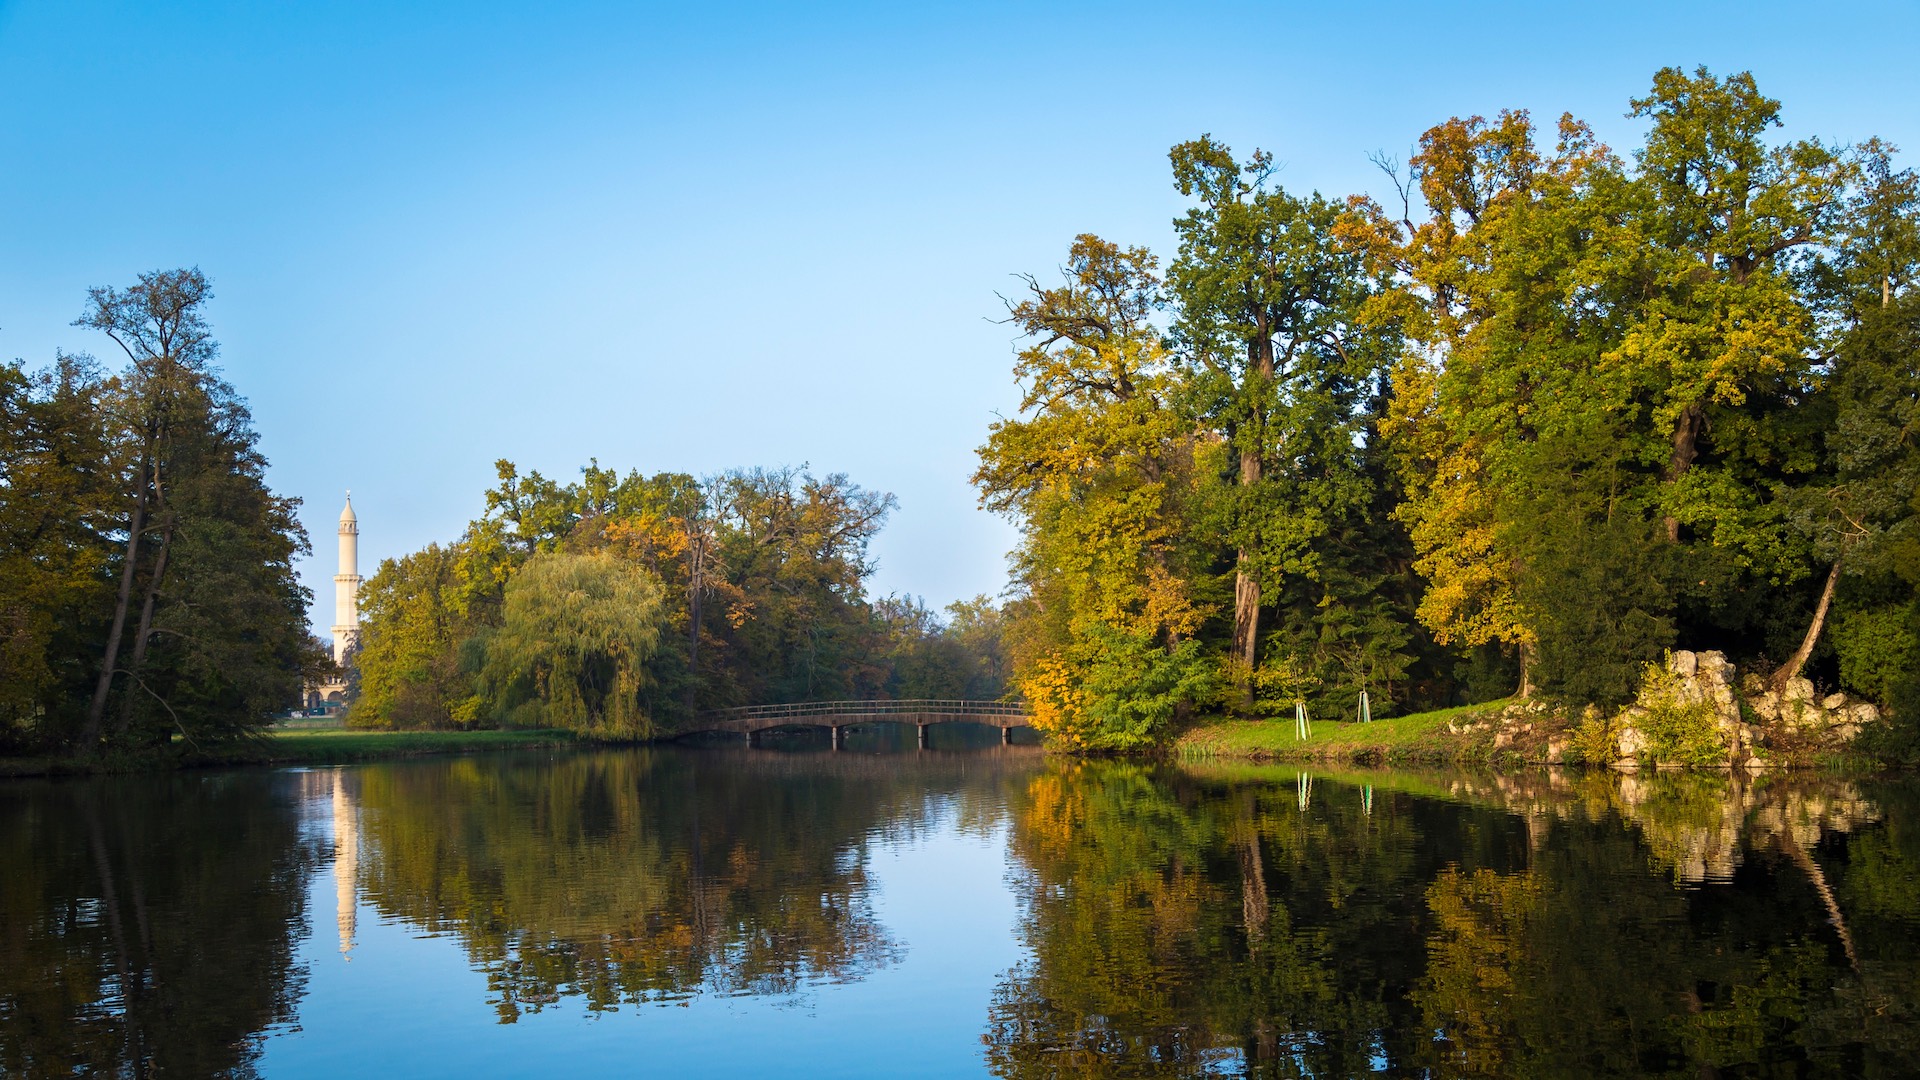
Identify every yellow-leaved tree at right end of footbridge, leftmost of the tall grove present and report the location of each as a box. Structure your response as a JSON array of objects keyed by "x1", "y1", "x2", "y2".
[{"x1": 973, "y1": 234, "x2": 1221, "y2": 740}]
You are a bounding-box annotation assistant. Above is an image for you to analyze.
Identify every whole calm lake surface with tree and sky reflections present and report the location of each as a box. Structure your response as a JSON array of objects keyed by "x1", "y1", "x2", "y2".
[{"x1": 0, "y1": 726, "x2": 1920, "y2": 1078}]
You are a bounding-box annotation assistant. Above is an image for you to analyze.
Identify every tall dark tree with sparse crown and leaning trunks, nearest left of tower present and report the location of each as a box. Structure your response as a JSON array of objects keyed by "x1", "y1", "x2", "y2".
[{"x1": 60, "y1": 269, "x2": 319, "y2": 753}]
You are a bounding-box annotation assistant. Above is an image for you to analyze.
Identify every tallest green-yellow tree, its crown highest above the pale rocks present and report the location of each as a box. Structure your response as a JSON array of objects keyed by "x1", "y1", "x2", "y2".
[{"x1": 1609, "y1": 67, "x2": 1851, "y2": 542}]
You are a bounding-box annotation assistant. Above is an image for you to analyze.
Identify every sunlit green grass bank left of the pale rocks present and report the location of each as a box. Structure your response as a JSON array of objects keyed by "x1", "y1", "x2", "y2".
[{"x1": 1173, "y1": 700, "x2": 1507, "y2": 761}]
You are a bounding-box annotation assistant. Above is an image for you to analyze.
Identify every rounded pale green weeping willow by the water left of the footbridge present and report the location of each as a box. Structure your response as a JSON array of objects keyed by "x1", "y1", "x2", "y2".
[{"x1": 476, "y1": 552, "x2": 666, "y2": 738}]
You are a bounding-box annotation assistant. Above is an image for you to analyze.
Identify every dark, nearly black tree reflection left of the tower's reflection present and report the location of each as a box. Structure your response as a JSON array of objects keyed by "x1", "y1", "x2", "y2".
[{"x1": 0, "y1": 773, "x2": 321, "y2": 1076}]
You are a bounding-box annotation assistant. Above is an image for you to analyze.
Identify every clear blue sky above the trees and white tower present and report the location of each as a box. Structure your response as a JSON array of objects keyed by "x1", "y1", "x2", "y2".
[{"x1": 0, "y1": 0, "x2": 1920, "y2": 626}]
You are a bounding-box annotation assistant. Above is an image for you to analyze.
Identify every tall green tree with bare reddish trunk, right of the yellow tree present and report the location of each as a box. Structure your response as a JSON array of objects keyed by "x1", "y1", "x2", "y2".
[{"x1": 1167, "y1": 136, "x2": 1394, "y2": 705}]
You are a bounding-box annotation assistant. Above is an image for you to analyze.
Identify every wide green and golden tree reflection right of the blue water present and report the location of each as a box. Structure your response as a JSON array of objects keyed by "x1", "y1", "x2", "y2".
[{"x1": 987, "y1": 763, "x2": 1920, "y2": 1076}]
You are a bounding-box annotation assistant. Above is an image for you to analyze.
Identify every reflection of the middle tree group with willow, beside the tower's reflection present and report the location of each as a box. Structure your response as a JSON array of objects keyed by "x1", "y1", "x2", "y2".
[{"x1": 344, "y1": 737, "x2": 1033, "y2": 1022}]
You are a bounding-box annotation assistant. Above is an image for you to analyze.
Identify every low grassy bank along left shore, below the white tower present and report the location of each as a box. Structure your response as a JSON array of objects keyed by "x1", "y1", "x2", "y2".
[{"x1": 0, "y1": 728, "x2": 580, "y2": 778}]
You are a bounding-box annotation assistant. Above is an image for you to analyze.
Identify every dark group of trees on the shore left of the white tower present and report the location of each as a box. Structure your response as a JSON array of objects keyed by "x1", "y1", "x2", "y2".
[{"x1": 0, "y1": 269, "x2": 314, "y2": 755}]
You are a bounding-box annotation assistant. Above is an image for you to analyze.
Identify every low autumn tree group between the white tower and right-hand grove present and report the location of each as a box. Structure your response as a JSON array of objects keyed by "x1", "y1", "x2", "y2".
[{"x1": 348, "y1": 461, "x2": 1006, "y2": 738}]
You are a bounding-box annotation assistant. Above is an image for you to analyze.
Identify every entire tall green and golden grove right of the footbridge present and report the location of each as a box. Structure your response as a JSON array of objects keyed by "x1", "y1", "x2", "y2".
[{"x1": 975, "y1": 69, "x2": 1920, "y2": 749}]
